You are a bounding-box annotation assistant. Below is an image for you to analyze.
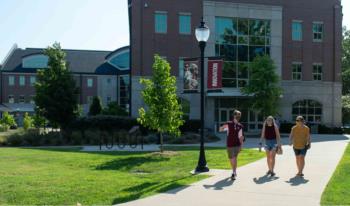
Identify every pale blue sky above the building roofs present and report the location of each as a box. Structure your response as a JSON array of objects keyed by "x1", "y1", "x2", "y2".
[{"x1": 0, "y1": 0, "x2": 350, "y2": 64}]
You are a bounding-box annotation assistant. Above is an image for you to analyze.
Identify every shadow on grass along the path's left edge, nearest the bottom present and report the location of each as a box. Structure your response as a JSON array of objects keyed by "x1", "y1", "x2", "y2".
[{"x1": 112, "y1": 176, "x2": 189, "y2": 205}]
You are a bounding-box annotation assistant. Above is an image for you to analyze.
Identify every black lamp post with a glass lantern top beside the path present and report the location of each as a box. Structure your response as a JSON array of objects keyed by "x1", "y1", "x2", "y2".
[{"x1": 196, "y1": 19, "x2": 210, "y2": 173}]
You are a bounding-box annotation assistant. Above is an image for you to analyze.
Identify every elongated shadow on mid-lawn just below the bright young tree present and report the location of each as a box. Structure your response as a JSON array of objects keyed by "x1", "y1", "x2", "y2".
[{"x1": 96, "y1": 156, "x2": 170, "y2": 170}]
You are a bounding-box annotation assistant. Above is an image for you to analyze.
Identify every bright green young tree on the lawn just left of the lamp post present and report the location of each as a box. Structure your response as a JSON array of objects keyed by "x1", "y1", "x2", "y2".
[{"x1": 137, "y1": 55, "x2": 184, "y2": 152}]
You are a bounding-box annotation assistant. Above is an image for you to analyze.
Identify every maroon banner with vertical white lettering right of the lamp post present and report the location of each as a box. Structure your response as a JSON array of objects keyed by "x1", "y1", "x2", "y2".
[{"x1": 208, "y1": 59, "x2": 224, "y2": 89}]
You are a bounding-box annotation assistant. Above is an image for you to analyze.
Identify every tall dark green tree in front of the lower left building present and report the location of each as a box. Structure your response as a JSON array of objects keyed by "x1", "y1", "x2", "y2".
[{"x1": 34, "y1": 43, "x2": 79, "y2": 131}]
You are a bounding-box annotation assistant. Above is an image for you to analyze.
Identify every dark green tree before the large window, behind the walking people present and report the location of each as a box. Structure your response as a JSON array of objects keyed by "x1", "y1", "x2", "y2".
[{"x1": 241, "y1": 55, "x2": 282, "y2": 116}]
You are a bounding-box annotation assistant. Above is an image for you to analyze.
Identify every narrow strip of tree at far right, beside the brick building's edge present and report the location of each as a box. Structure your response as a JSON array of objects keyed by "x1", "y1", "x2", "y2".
[{"x1": 341, "y1": 27, "x2": 350, "y2": 95}]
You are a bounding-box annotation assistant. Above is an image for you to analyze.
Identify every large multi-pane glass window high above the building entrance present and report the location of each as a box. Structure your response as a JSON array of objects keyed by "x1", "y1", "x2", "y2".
[{"x1": 215, "y1": 17, "x2": 271, "y2": 88}]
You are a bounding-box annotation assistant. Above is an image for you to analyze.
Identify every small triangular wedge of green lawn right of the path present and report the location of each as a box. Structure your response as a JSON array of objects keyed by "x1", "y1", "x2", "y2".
[{"x1": 321, "y1": 144, "x2": 350, "y2": 205}]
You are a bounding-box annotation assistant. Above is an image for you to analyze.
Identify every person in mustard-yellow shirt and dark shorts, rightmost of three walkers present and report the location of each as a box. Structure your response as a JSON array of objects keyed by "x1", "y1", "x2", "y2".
[{"x1": 289, "y1": 116, "x2": 311, "y2": 177}]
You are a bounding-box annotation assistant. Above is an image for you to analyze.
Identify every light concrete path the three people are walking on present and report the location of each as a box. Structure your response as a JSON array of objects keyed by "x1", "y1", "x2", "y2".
[{"x1": 121, "y1": 136, "x2": 349, "y2": 206}]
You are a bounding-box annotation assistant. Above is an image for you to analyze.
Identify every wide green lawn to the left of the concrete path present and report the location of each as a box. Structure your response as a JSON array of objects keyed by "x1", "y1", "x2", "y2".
[{"x1": 0, "y1": 148, "x2": 264, "y2": 205}]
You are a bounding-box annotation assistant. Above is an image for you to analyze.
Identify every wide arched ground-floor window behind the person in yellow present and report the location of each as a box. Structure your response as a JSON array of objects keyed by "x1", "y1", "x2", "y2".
[{"x1": 292, "y1": 100, "x2": 322, "y2": 123}]
